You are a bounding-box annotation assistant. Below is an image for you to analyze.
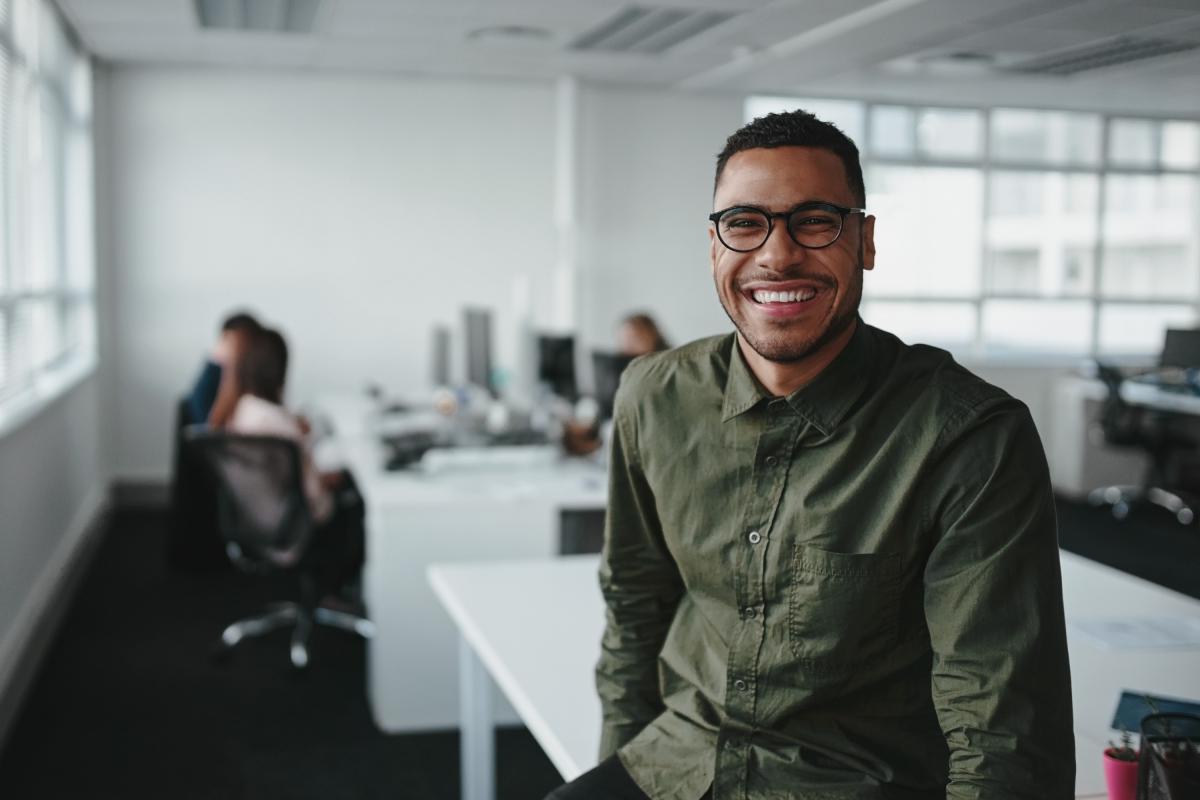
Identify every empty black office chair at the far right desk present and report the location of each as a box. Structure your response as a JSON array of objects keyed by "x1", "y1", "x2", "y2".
[{"x1": 1088, "y1": 363, "x2": 1196, "y2": 525}]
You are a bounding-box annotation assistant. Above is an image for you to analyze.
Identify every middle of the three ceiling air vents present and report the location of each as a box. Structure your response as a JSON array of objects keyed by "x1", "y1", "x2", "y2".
[{"x1": 569, "y1": 6, "x2": 737, "y2": 54}]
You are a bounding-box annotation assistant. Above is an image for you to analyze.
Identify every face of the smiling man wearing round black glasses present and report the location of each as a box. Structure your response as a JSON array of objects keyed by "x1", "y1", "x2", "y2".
[{"x1": 708, "y1": 148, "x2": 875, "y2": 362}]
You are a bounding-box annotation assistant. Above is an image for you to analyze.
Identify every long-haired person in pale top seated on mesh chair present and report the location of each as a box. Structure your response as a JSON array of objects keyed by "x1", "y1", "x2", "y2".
[{"x1": 224, "y1": 329, "x2": 366, "y2": 606}]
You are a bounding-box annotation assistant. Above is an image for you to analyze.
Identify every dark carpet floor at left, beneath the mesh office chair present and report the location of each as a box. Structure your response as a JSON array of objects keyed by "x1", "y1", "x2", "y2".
[{"x1": 0, "y1": 512, "x2": 560, "y2": 800}]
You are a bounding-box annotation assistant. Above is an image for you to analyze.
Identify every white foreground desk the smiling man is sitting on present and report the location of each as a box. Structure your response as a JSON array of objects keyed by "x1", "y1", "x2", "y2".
[{"x1": 428, "y1": 553, "x2": 1200, "y2": 800}]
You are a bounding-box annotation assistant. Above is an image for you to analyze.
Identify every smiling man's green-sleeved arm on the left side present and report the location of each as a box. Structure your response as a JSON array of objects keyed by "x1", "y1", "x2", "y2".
[{"x1": 596, "y1": 403, "x2": 683, "y2": 759}]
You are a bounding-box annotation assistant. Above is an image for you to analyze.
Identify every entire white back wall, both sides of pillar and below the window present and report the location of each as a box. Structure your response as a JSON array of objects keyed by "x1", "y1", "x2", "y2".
[{"x1": 98, "y1": 67, "x2": 1080, "y2": 481}]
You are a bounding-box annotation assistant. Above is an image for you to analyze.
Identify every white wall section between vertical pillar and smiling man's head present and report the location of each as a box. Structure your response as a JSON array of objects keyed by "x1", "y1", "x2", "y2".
[{"x1": 580, "y1": 86, "x2": 743, "y2": 348}]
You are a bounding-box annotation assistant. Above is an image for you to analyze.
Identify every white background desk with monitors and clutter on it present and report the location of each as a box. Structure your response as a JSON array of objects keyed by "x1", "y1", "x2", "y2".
[{"x1": 319, "y1": 398, "x2": 607, "y2": 733}]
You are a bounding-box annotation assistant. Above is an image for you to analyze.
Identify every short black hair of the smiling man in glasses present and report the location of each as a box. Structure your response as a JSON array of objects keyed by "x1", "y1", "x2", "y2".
[{"x1": 713, "y1": 109, "x2": 866, "y2": 206}]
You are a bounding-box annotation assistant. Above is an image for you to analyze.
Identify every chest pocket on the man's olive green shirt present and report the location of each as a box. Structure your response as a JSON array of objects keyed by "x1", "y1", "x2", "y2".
[{"x1": 787, "y1": 543, "x2": 902, "y2": 673}]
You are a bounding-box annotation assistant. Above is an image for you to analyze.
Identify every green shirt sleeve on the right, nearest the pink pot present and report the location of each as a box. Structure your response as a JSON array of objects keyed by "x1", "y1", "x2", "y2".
[{"x1": 924, "y1": 399, "x2": 1075, "y2": 800}]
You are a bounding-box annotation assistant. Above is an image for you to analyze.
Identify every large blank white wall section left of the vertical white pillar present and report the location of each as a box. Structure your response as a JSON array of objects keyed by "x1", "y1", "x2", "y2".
[{"x1": 102, "y1": 67, "x2": 554, "y2": 480}]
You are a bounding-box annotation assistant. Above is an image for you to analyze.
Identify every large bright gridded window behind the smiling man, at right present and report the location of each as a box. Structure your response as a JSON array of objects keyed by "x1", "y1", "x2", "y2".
[{"x1": 746, "y1": 97, "x2": 1200, "y2": 357}]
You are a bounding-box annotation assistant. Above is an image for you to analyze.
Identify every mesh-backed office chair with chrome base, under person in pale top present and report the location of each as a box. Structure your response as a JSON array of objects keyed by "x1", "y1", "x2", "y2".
[{"x1": 187, "y1": 429, "x2": 374, "y2": 669}]
